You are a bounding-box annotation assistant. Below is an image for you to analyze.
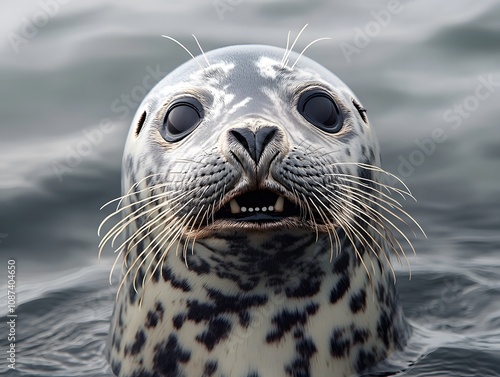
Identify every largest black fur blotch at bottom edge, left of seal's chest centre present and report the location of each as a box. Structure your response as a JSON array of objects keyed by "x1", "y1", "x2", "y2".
[{"x1": 153, "y1": 334, "x2": 191, "y2": 377}]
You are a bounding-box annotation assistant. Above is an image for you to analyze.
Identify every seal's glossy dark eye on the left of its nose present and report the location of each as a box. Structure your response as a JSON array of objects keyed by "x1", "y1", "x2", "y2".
[{"x1": 162, "y1": 97, "x2": 203, "y2": 142}]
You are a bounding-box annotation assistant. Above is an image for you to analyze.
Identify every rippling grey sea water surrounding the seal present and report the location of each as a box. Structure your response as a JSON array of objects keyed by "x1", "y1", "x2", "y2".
[{"x1": 0, "y1": 0, "x2": 500, "y2": 377}]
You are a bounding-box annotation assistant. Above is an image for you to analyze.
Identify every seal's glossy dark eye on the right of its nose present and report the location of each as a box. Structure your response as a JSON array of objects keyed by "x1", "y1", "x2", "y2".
[{"x1": 297, "y1": 90, "x2": 342, "y2": 133}]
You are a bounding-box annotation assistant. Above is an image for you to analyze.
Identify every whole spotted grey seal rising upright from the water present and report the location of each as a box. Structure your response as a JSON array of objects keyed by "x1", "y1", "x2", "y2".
[{"x1": 102, "y1": 45, "x2": 418, "y2": 377}]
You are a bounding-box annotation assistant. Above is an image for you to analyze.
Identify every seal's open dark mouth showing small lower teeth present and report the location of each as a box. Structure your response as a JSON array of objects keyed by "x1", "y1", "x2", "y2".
[{"x1": 215, "y1": 190, "x2": 300, "y2": 222}]
